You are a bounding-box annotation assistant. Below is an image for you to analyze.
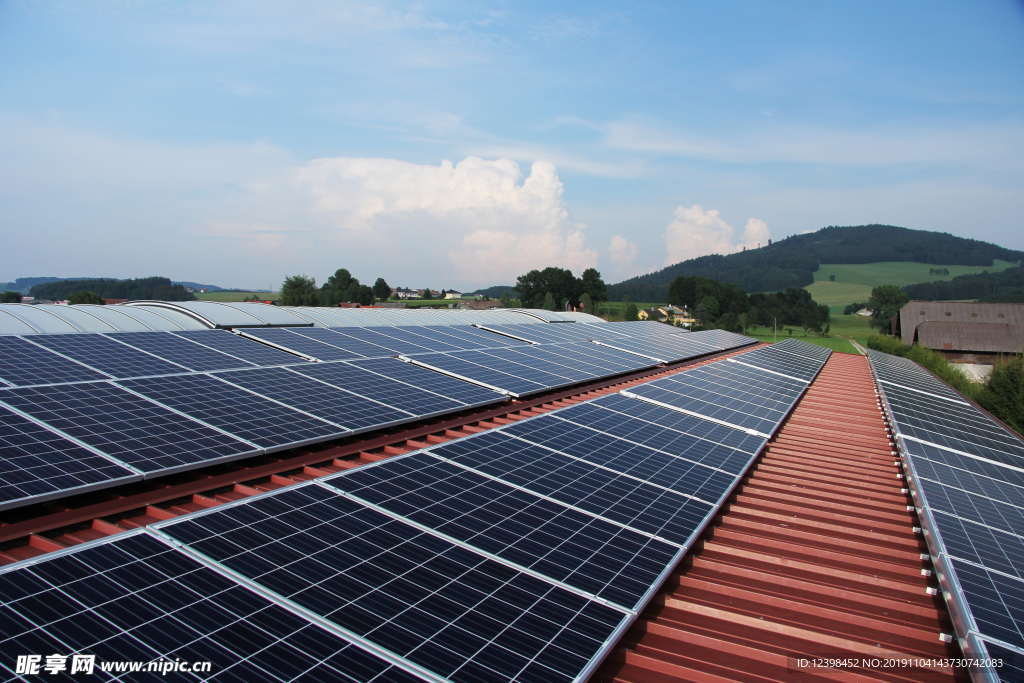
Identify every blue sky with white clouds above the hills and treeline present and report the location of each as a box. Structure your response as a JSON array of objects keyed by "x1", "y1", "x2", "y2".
[{"x1": 0, "y1": 0, "x2": 1024, "y2": 291}]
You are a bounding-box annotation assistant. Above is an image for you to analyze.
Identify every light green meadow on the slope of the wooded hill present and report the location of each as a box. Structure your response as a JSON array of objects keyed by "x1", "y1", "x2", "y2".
[{"x1": 804, "y1": 261, "x2": 1016, "y2": 315}]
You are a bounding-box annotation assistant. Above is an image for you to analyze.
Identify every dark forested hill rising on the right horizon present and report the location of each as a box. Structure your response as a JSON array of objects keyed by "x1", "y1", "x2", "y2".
[{"x1": 608, "y1": 225, "x2": 1024, "y2": 305}]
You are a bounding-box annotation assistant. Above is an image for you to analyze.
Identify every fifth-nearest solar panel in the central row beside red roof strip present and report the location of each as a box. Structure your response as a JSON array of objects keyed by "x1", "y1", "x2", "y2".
[{"x1": 502, "y1": 415, "x2": 735, "y2": 504}]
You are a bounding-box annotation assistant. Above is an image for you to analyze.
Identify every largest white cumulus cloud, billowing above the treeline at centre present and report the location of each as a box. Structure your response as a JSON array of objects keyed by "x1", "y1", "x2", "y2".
[{"x1": 218, "y1": 157, "x2": 597, "y2": 287}]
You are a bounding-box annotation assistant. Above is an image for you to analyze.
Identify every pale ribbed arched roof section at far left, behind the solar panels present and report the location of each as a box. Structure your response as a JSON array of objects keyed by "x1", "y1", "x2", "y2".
[{"x1": 0, "y1": 303, "x2": 208, "y2": 335}]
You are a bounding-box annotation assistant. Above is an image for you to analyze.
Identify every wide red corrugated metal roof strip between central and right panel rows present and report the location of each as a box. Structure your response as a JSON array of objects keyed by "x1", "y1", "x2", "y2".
[{"x1": 598, "y1": 353, "x2": 964, "y2": 682}]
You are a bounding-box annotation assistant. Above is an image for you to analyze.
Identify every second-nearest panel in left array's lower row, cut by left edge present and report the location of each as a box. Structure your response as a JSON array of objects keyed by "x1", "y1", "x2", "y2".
[{"x1": 3, "y1": 382, "x2": 259, "y2": 474}]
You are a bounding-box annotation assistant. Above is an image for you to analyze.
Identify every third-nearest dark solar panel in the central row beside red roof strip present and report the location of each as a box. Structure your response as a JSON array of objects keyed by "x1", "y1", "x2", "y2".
[{"x1": 327, "y1": 454, "x2": 679, "y2": 608}]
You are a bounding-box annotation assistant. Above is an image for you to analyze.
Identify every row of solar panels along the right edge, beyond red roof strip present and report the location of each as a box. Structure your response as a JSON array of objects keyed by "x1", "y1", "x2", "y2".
[{"x1": 868, "y1": 350, "x2": 1024, "y2": 681}]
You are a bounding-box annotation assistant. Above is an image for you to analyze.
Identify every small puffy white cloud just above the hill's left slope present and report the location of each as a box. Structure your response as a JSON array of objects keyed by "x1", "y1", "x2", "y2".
[{"x1": 665, "y1": 204, "x2": 771, "y2": 265}]
